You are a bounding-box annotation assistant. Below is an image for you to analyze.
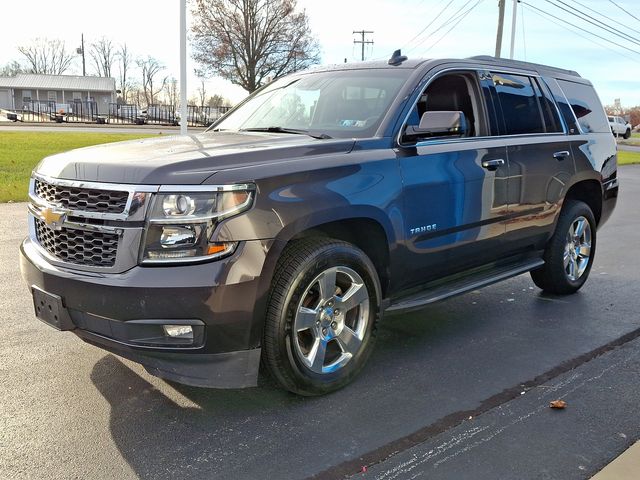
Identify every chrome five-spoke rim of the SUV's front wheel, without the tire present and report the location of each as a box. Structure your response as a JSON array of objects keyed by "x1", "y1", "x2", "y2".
[{"x1": 292, "y1": 266, "x2": 370, "y2": 374}]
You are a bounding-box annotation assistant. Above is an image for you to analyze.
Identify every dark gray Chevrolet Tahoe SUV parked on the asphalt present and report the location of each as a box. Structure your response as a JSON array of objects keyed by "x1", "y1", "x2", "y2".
[{"x1": 21, "y1": 52, "x2": 618, "y2": 395}]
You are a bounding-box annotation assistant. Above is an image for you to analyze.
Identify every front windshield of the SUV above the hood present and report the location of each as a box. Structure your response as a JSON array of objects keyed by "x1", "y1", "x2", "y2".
[{"x1": 213, "y1": 69, "x2": 410, "y2": 138}]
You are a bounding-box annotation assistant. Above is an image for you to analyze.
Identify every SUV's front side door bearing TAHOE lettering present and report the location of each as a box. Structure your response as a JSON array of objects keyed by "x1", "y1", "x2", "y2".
[{"x1": 399, "y1": 72, "x2": 508, "y2": 284}]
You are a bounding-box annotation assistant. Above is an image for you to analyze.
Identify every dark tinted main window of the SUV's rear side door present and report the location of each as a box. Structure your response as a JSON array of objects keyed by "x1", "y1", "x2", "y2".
[{"x1": 493, "y1": 73, "x2": 545, "y2": 135}]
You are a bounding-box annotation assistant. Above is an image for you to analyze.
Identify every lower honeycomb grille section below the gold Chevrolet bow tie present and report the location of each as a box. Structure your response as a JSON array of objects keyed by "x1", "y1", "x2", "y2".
[{"x1": 35, "y1": 218, "x2": 118, "y2": 267}]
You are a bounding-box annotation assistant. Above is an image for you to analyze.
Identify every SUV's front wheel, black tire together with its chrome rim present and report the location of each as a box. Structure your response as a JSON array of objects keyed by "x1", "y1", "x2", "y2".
[{"x1": 262, "y1": 238, "x2": 380, "y2": 396}]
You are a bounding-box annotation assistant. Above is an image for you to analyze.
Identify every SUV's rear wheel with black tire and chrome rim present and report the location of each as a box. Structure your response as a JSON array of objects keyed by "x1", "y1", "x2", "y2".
[{"x1": 531, "y1": 200, "x2": 596, "y2": 295}]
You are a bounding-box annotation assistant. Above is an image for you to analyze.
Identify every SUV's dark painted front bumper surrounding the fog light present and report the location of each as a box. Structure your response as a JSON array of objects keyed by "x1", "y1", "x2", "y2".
[{"x1": 20, "y1": 239, "x2": 271, "y2": 388}]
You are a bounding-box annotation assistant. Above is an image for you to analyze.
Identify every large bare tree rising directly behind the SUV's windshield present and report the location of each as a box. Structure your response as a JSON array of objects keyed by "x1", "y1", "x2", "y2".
[{"x1": 191, "y1": 0, "x2": 320, "y2": 92}]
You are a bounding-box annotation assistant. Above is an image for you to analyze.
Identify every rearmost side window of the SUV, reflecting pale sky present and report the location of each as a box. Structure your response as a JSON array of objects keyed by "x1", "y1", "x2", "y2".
[{"x1": 558, "y1": 80, "x2": 611, "y2": 133}]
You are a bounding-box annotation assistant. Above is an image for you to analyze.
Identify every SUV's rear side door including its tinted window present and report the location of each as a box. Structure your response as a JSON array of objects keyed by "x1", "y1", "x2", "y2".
[{"x1": 491, "y1": 72, "x2": 575, "y2": 253}]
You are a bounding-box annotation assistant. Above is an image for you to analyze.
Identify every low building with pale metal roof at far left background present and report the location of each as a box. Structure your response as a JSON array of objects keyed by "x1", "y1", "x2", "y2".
[{"x1": 0, "y1": 73, "x2": 116, "y2": 115}]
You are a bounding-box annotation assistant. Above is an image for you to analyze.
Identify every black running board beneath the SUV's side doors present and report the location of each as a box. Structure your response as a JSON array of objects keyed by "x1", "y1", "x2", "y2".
[{"x1": 385, "y1": 258, "x2": 544, "y2": 314}]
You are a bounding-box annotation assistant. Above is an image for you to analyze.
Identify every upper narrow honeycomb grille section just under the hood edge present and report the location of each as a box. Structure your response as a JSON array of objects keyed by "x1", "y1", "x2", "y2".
[{"x1": 35, "y1": 180, "x2": 129, "y2": 213}]
